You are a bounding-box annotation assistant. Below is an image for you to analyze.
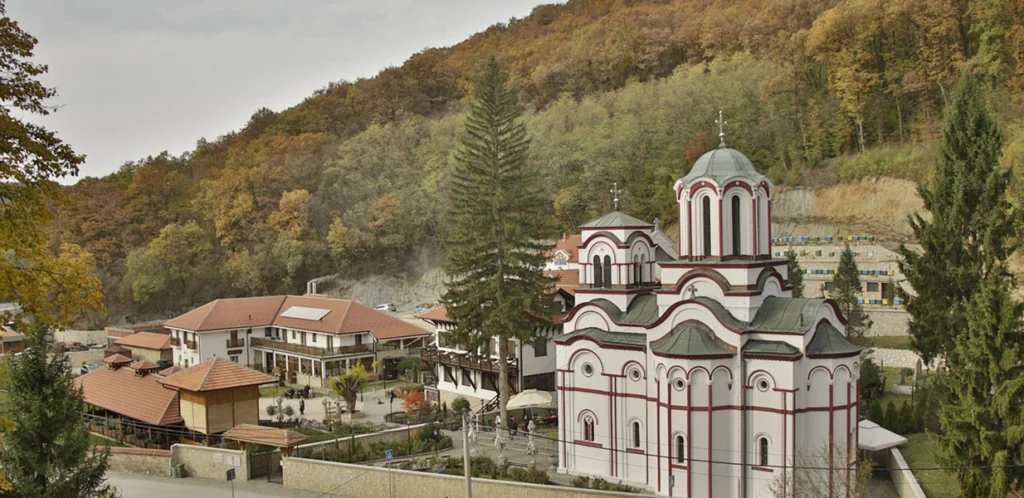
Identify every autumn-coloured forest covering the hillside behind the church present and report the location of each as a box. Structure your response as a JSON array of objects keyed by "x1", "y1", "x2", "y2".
[{"x1": 50, "y1": 0, "x2": 1024, "y2": 325}]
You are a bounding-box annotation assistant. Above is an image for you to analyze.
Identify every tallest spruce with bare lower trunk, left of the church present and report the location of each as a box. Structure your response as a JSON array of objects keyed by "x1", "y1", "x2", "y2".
[{"x1": 442, "y1": 57, "x2": 555, "y2": 421}]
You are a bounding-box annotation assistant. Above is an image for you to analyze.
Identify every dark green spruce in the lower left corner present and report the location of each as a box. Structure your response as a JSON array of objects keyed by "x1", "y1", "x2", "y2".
[{"x1": 0, "y1": 325, "x2": 106, "y2": 498}]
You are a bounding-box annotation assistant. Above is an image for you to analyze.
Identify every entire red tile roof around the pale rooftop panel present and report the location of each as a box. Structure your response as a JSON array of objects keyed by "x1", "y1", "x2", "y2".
[{"x1": 167, "y1": 296, "x2": 431, "y2": 340}]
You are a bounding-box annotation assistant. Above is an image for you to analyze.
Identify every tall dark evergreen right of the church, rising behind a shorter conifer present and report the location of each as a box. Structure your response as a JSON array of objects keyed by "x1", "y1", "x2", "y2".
[{"x1": 898, "y1": 72, "x2": 1014, "y2": 362}]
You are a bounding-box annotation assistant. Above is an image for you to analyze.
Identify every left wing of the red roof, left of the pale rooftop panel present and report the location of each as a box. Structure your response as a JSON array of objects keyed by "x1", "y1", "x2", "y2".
[{"x1": 164, "y1": 296, "x2": 285, "y2": 332}]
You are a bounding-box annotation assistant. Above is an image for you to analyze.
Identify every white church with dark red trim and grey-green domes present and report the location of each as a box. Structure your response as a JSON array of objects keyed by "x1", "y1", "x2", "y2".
[{"x1": 556, "y1": 130, "x2": 860, "y2": 497}]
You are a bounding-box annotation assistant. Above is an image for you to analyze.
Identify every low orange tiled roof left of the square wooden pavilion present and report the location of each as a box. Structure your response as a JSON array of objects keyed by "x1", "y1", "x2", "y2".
[{"x1": 75, "y1": 368, "x2": 182, "y2": 425}]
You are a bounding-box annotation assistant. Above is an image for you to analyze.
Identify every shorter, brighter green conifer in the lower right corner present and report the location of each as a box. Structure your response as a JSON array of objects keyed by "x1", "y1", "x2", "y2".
[{"x1": 938, "y1": 267, "x2": 1024, "y2": 498}]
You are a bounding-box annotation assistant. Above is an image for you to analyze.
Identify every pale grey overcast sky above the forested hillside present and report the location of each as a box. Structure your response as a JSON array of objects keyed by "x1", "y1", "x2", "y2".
[{"x1": 6, "y1": 0, "x2": 556, "y2": 181}]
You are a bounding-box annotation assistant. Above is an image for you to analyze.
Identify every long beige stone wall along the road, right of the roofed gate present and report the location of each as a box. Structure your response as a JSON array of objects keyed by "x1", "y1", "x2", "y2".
[{"x1": 283, "y1": 458, "x2": 638, "y2": 498}]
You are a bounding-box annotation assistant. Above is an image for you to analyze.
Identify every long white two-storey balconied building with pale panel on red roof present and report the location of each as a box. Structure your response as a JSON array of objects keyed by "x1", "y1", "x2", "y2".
[{"x1": 164, "y1": 296, "x2": 432, "y2": 387}]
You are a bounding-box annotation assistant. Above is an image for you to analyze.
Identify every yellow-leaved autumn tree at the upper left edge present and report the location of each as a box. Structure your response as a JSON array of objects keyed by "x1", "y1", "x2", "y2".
[{"x1": 0, "y1": 1, "x2": 102, "y2": 326}]
